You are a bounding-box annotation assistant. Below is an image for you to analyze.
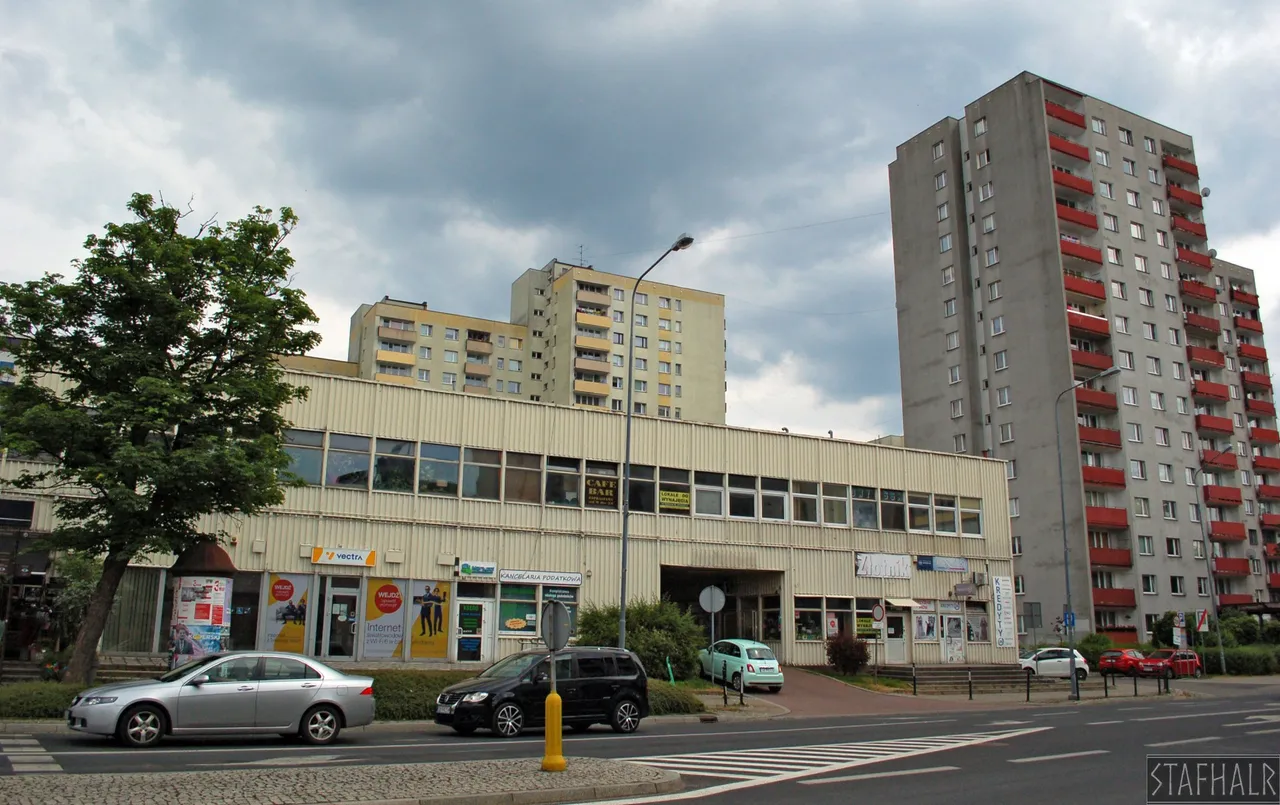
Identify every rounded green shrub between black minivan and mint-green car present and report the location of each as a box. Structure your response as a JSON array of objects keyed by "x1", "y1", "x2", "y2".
[{"x1": 577, "y1": 599, "x2": 707, "y2": 680}]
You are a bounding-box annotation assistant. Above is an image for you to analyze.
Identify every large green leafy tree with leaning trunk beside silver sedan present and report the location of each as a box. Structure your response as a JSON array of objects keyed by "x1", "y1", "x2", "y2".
[{"x1": 0, "y1": 195, "x2": 320, "y2": 683}]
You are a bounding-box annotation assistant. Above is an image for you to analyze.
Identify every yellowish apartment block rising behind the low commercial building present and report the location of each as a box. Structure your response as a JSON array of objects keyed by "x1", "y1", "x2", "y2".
[{"x1": 347, "y1": 260, "x2": 726, "y2": 424}]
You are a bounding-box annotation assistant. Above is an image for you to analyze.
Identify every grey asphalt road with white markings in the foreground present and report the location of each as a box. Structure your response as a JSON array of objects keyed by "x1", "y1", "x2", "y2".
[{"x1": 0, "y1": 686, "x2": 1280, "y2": 805}]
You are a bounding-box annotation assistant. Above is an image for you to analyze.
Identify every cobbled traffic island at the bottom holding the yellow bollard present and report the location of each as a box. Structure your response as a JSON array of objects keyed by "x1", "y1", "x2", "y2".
[{"x1": 0, "y1": 758, "x2": 684, "y2": 805}]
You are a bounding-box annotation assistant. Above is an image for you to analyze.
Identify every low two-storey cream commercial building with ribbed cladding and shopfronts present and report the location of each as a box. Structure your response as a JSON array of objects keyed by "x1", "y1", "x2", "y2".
[{"x1": 0, "y1": 371, "x2": 1018, "y2": 666}]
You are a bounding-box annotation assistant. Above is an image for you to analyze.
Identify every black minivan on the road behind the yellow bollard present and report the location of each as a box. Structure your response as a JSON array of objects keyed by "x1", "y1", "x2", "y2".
[{"x1": 435, "y1": 646, "x2": 649, "y2": 738}]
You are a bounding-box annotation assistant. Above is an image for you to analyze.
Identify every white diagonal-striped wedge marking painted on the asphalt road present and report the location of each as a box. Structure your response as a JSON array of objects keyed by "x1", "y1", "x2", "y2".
[{"x1": 627, "y1": 727, "x2": 1047, "y2": 787}]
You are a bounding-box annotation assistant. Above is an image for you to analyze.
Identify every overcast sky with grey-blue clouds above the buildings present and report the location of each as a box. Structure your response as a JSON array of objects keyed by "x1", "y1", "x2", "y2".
[{"x1": 0, "y1": 0, "x2": 1280, "y2": 439}]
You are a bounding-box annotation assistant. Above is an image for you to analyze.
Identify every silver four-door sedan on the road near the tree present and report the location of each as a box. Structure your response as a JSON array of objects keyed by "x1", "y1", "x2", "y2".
[{"x1": 67, "y1": 651, "x2": 374, "y2": 747}]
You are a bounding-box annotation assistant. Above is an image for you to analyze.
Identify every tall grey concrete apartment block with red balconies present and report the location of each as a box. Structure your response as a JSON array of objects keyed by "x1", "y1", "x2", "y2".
[{"x1": 890, "y1": 73, "x2": 1280, "y2": 642}]
